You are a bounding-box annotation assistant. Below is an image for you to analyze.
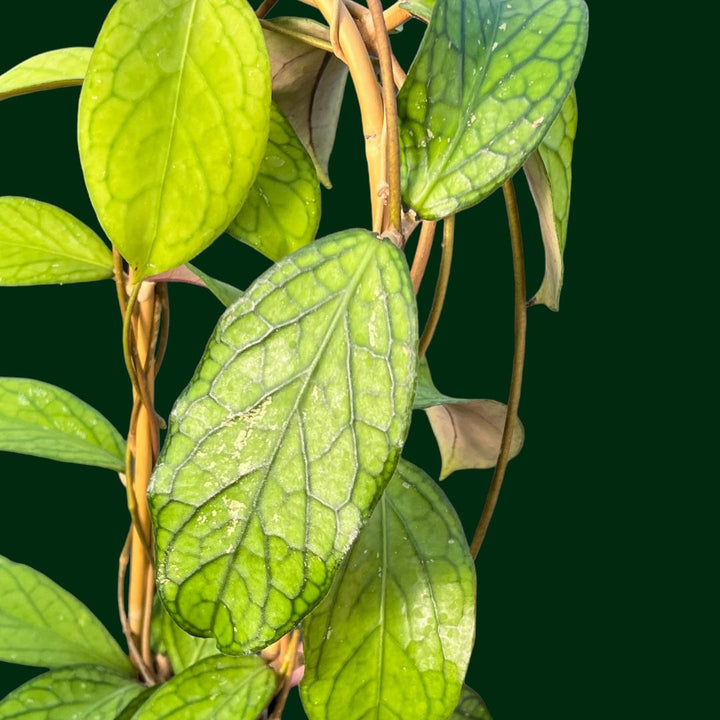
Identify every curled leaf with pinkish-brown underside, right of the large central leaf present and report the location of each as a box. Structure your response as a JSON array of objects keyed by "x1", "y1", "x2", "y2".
[{"x1": 413, "y1": 358, "x2": 525, "y2": 480}]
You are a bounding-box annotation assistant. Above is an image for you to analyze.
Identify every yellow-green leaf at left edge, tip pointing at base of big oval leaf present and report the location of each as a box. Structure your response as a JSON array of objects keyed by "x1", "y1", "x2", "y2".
[{"x1": 0, "y1": 196, "x2": 112, "y2": 285}]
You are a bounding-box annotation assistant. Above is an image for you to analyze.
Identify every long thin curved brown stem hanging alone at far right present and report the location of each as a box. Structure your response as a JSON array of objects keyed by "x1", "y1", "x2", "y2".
[{"x1": 470, "y1": 179, "x2": 527, "y2": 559}]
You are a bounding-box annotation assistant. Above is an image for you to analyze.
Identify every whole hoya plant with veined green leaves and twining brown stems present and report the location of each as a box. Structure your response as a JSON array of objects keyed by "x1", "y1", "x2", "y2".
[{"x1": 0, "y1": 0, "x2": 588, "y2": 720}]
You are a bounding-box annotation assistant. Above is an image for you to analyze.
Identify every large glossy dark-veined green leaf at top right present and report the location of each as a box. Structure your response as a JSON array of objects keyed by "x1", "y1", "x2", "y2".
[{"x1": 398, "y1": 0, "x2": 587, "y2": 220}]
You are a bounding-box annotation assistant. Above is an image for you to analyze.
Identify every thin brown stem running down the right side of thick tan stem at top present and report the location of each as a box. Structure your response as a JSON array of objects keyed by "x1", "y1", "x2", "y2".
[{"x1": 367, "y1": 0, "x2": 401, "y2": 235}]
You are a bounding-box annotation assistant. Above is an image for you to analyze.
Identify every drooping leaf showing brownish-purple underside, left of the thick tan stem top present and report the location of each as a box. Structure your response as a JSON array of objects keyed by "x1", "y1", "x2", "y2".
[{"x1": 263, "y1": 18, "x2": 347, "y2": 188}]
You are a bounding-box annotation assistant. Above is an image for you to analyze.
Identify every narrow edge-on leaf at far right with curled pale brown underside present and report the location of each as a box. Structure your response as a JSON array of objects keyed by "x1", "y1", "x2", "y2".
[{"x1": 525, "y1": 90, "x2": 577, "y2": 310}]
